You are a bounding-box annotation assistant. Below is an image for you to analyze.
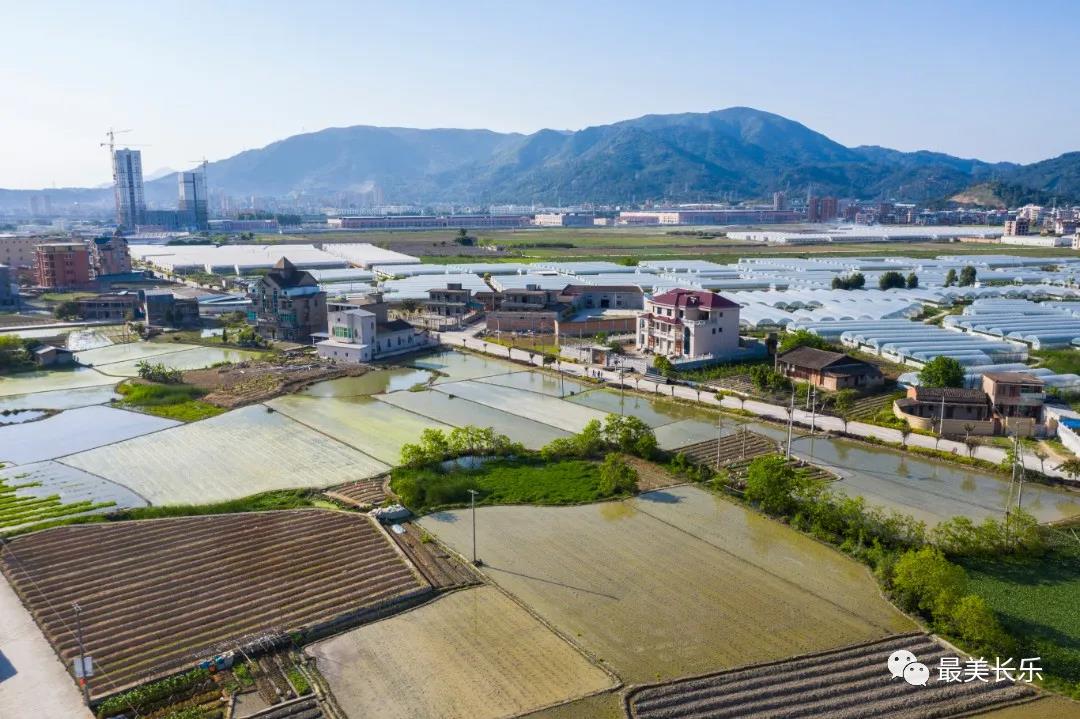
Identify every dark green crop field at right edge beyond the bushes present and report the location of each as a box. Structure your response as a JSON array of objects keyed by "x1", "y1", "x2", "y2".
[{"x1": 960, "y1": 553, "x2": 1080, "y2": 697}]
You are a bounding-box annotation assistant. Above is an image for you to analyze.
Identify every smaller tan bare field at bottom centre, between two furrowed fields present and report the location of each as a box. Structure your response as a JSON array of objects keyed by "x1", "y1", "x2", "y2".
[{"x1": 307, "y1": 586, "x2": 616, "y2": 719}]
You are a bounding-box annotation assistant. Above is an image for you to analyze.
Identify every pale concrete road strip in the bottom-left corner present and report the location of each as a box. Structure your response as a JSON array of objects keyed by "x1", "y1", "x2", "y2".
[{"x1": 0, "y1": 575, "x2": 93, "y2": 719}]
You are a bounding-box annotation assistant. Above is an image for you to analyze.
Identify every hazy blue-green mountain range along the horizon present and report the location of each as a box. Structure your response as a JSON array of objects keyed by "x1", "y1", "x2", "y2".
[{"x1": 0, "y1": 107, "x2": 1080, "y2": 208}]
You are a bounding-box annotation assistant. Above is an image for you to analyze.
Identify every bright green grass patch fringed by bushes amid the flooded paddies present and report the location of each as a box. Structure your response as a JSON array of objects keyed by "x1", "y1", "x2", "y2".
[{"x1": 390, "y1": 459, "x2": 608, "y2": 513}]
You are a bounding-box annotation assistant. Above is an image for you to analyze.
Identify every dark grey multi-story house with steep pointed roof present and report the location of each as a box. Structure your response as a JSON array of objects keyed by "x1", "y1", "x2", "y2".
[{"x1": 252, "y1": 257, "x2": 326, "y2": 344}]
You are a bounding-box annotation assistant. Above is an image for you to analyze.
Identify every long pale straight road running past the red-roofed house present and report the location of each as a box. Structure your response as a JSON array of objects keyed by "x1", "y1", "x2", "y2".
[{"x1": 442, "y1": 332, "x2": 1065, "y2": 477}]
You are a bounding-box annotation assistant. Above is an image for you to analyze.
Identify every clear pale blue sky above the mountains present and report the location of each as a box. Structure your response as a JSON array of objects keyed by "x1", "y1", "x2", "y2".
[{"x1": 0, "y1": 0, "x2": 1080, "y2": 189}]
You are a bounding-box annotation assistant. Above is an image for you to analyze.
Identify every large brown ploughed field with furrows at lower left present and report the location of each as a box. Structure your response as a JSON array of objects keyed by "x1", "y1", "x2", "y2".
[{"x1": 0, "y1": 510, "x2": 427, "y2": 695}]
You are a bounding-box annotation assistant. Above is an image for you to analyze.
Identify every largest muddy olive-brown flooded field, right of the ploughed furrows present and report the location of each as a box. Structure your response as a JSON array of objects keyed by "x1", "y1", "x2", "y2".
[{"x1": 421, "y1": 487, "x2": 915, "y2": 682}]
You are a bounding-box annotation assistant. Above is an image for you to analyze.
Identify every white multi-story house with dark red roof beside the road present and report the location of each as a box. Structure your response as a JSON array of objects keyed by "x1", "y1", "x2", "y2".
[{"x1": 637, "y1": 289, "x2": 739, "y2": 360}]
